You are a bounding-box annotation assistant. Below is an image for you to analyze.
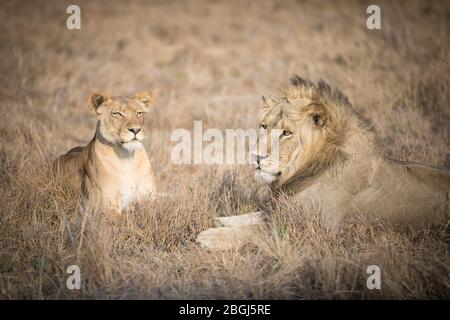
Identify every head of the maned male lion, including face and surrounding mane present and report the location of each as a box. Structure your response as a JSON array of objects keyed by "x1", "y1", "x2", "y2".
[{"x1": 252, "y1": 76, "x2": 356, "y2": 187}]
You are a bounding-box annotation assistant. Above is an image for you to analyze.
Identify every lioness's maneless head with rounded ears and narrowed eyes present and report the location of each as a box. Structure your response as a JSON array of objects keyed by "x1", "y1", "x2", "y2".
[{"x1": 88, "y1": 91, "x2": 154, "y2": 151}]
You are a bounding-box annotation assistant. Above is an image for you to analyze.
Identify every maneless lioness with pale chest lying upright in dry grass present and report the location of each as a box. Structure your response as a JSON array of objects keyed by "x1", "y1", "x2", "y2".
[{"x1": 55, "y1": 91, "x2": 156, "y2": 215}]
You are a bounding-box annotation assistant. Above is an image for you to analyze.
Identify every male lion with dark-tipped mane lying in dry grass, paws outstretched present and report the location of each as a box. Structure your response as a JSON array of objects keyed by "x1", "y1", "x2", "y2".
[{"x1": 197, "y1": 76, "x2": 450, "y2": 249}]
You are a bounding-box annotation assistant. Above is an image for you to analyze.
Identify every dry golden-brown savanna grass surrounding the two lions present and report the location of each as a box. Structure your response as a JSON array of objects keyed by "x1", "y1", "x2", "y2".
[{"x1": 0, "y1": 1, "x2": 450, "y2": 299}]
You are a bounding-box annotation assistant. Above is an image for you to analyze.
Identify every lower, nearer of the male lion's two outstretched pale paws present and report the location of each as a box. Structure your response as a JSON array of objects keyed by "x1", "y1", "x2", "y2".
[{"x1": 195, "y1": 227, "x2": 255, "y2": 251}]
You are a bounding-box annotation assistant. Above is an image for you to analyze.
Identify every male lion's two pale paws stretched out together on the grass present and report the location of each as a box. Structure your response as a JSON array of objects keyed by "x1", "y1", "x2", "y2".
[{"x1": 195, "y1": 211, "x2": 265, "y2": 251}]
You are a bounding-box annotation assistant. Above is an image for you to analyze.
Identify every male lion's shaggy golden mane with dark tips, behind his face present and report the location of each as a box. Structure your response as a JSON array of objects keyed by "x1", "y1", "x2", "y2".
[{"x1": 276, "y1": 75, "x2": 382, "y2": 190}]
